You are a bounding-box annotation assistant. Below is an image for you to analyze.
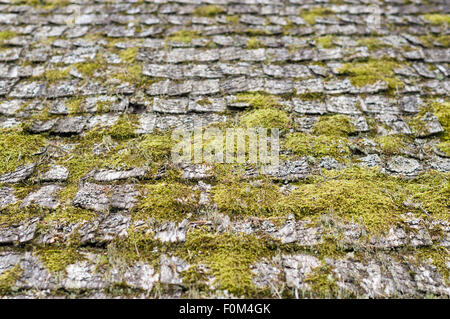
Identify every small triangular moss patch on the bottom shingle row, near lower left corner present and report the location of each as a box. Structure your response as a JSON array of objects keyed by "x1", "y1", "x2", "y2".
[{"x1": 36, "y1": 247, "x2": 83, "y2": 273}]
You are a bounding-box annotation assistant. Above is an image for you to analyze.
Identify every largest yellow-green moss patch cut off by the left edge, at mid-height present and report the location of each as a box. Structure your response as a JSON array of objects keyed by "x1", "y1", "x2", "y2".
[{"x1": 0, "y1": 129, "x2": 47, "y2": 174}]
